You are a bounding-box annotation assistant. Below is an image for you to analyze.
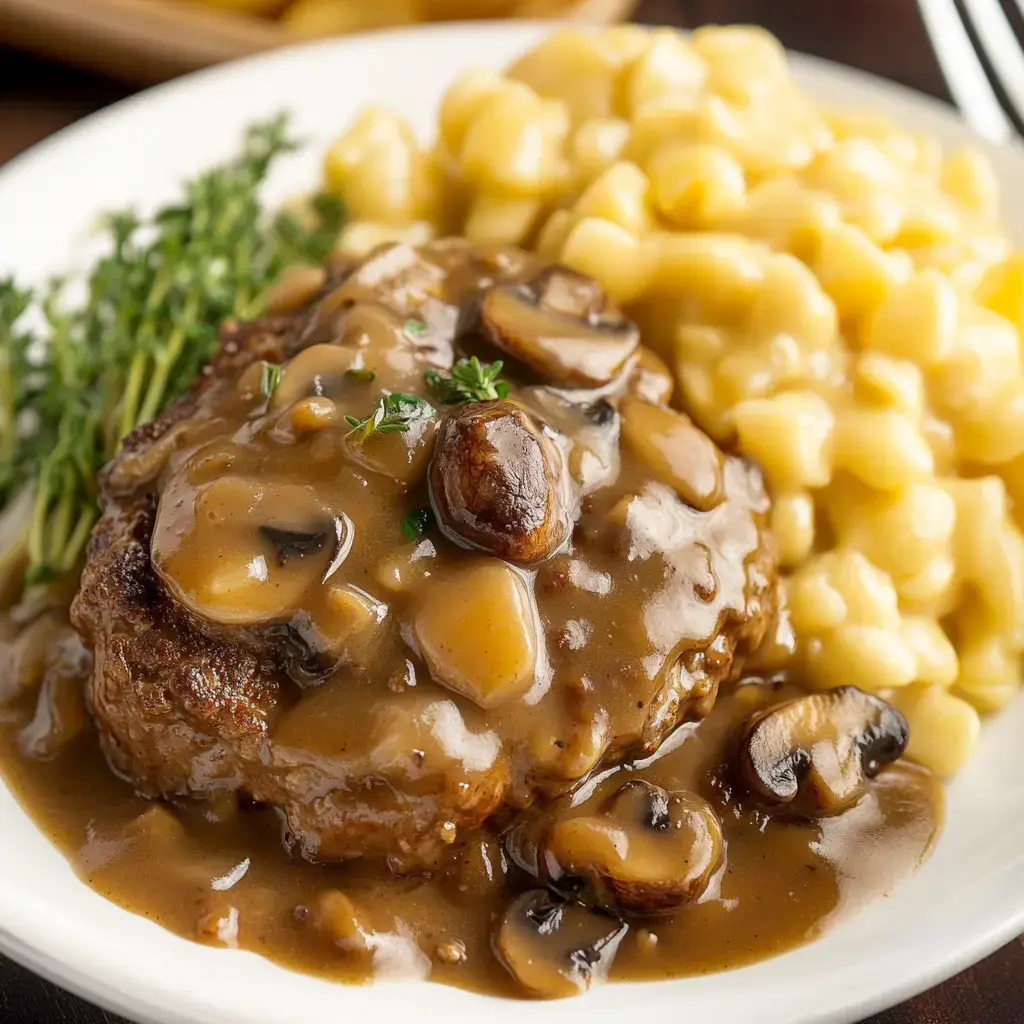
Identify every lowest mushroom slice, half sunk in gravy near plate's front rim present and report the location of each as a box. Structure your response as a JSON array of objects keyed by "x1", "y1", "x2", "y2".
[{"x1": 495, "y1": 889, "x2": 629, "y2": 999}]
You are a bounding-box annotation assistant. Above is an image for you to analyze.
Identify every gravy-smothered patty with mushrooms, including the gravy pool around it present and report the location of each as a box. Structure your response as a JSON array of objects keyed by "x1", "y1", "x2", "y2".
[{"x1": 0, "y1": 241, "x2": 941, "y2": 996}]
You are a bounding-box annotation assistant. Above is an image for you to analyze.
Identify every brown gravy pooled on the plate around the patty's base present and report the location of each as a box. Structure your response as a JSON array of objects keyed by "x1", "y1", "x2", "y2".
[{"x1": 0, "y1": 685, "x2": 941, "y2": 996}]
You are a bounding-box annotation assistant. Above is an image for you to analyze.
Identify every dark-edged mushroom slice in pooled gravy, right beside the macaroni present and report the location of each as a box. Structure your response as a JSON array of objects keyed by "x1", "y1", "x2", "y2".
[{"x1": 739, "y1": 686, "x2": 909, "y2": 815}]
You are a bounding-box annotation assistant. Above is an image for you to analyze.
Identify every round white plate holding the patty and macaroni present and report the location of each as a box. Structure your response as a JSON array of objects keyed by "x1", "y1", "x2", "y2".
[{"x1": 0, "y1": 25, "x2": 1024, "y2": 1024}]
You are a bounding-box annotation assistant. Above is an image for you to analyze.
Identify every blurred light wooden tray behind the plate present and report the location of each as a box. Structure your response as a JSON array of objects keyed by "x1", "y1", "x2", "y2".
[{"x1": 0, "y1": 0, "x2": 636, "y2": 83}]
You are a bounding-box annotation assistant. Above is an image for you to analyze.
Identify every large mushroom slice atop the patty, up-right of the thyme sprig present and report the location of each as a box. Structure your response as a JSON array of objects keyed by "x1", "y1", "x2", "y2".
[{"x1": 480, "y1": 267, "x2": 640, "y2": 387}]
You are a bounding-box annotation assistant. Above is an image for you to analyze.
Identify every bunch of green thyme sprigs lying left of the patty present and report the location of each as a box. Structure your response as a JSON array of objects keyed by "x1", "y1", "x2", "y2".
[{"x1": 0, "y1": 116, "x2": 342, "y2": 584}]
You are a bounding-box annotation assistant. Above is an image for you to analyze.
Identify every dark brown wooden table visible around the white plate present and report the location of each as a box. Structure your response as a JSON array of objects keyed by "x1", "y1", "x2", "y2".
[{"x1": 0, "y1": 0, "x2": 1024, "y2": 1024}]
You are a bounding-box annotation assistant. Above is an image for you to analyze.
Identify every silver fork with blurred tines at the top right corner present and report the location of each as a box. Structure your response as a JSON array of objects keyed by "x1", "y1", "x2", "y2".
[{"x1": 918, "y1": 0, "x2": 1024, "y2": 142}]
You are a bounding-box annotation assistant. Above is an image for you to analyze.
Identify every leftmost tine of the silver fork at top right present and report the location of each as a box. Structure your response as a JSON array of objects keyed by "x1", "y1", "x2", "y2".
[{"x1": 918, "y1": 0, "x2": 1014, "y2": 142}]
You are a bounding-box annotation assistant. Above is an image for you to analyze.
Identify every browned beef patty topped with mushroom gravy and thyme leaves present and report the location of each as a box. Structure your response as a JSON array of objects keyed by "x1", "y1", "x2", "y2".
[{"x1": 73, "y1": 241, "x2": 775, "y2": 870}]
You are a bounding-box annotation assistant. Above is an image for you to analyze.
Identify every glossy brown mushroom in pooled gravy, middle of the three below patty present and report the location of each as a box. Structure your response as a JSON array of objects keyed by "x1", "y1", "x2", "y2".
[{"x1": 544, "y1": 779, "x2": 724, "y2": 915}]
